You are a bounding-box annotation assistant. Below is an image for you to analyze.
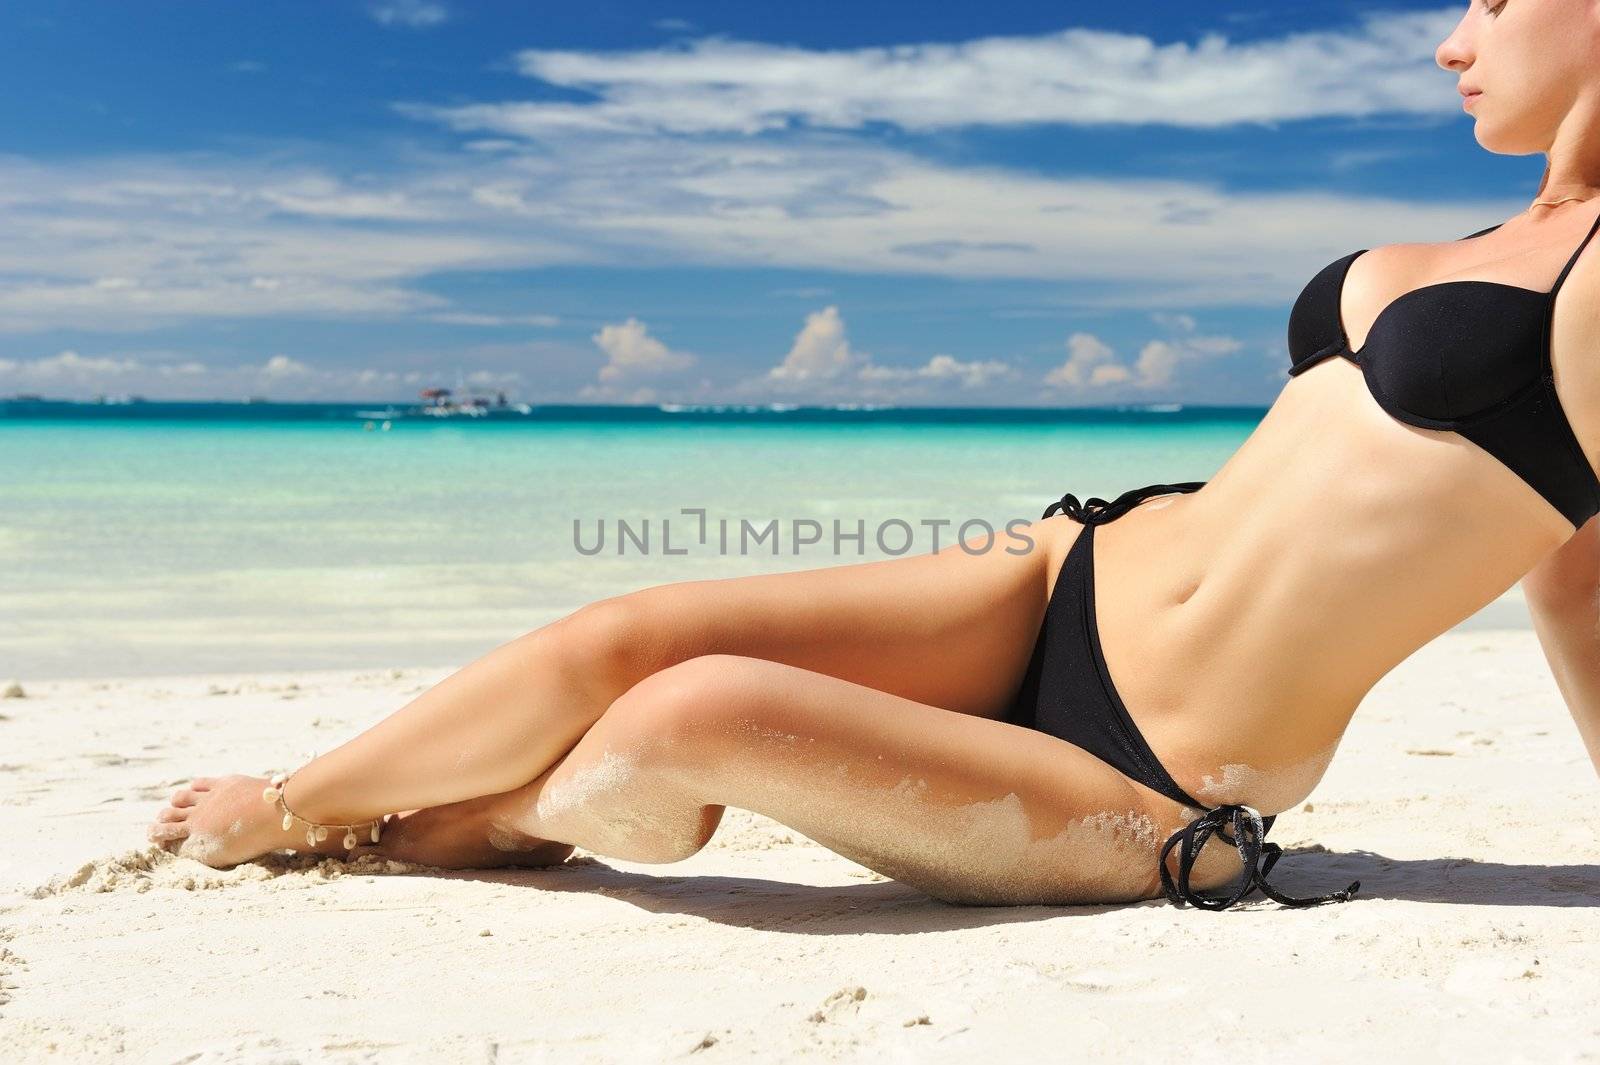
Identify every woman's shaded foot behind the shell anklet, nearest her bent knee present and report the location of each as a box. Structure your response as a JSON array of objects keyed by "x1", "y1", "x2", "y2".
[{"x1": 354, "y1": 795, "x2": 573, "y2": 868}]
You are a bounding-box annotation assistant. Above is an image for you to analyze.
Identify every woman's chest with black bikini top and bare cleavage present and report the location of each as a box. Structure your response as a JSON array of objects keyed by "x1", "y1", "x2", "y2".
[{"x1": 1288, "y1": 231, "x2": 1600, "y2": 525}]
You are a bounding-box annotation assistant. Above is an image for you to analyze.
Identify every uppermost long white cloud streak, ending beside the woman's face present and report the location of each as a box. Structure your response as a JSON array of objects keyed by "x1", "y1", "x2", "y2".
[{"x1": 409, "y1": 8, "x2": 1459, "y2": 136}]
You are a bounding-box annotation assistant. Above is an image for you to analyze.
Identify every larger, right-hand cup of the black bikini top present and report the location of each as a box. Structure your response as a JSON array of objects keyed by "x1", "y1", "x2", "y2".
[{"x1": 1352, "y1": 281, "x2": 1546, "y2": 427}]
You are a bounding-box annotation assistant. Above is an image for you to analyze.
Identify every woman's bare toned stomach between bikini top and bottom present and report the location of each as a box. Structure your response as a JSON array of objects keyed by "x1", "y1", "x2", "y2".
[{"x1": 1075, "y1": 358, "x2": 1573, "y2": 814}]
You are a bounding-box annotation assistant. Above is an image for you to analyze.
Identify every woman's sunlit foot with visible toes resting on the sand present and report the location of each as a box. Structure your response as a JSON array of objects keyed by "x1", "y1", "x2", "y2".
[{"x1": 146, "y1": 776, "x2": 382, "y2": 868}]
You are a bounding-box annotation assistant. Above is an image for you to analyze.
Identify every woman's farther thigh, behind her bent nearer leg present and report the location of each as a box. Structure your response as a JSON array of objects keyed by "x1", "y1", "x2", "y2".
[{"x1": 573, "y1": 515, "x2": 1082, "y2": 718}]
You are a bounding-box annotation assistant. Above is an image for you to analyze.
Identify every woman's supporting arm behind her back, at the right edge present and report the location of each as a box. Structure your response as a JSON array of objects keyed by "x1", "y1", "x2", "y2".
[{"x1": 1522, "y1": 515, "x2": 1600, "y2": 772}]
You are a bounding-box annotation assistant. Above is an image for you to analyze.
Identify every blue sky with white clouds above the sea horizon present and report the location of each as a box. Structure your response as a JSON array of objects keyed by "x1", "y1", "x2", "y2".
[{"x1": 0, "y1": 0, "x2": 1544, "y2": 406}]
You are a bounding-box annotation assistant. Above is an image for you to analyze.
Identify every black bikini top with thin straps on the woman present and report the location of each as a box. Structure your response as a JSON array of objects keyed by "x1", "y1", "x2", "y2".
[{"x1": 1290, "y1": 209, "x2": 1600, "y2": 529}]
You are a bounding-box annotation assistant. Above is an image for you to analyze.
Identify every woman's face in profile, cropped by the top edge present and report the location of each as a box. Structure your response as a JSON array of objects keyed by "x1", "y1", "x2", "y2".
[{"x1": 1434, "y1": 0, "x2": 1600, "y2": 155}]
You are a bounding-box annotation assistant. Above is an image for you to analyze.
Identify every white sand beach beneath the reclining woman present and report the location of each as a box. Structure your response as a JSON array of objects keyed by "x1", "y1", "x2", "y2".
[{"x1": 0, "y1": 630, "x2": 1600, "y2": 1062}]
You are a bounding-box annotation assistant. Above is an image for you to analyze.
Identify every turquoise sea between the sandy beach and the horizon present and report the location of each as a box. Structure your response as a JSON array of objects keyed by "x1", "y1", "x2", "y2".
[{"x1": 0, "y1": 401, "x2": 1516, "y2": 680}]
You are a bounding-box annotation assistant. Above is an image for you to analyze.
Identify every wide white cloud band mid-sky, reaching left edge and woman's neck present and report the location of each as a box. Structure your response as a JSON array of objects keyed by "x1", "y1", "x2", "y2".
[{"x1": 0, "y1": 138, "x2": 1520, "y2": 333}]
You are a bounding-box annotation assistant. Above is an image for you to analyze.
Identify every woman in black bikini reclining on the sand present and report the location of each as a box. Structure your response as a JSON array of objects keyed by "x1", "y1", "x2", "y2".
[{"x1": 150, "y1": 0, "x2": 1600, "y2": 908}]
